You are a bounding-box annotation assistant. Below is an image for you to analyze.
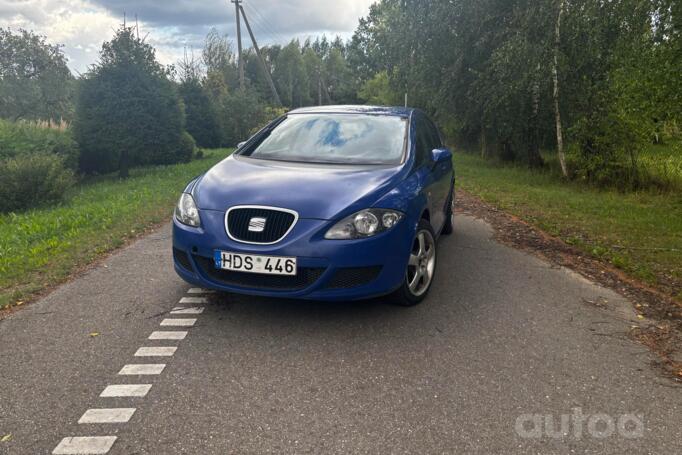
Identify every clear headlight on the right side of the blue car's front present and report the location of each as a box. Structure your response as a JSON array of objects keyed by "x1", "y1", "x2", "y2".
[{"x1": 324, "y1": 209, "x2": 404, "y2": 240}]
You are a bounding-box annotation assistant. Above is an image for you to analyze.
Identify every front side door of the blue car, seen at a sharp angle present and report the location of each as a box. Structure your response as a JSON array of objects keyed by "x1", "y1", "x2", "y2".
[{"x1": 415, "y1": 113, "x2": 445, "y2": 233}]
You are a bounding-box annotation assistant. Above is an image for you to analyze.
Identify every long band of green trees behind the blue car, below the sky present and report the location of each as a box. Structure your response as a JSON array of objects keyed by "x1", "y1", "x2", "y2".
[{"x1": 0, "y1": 0, "x2": 682, "y2": 200}]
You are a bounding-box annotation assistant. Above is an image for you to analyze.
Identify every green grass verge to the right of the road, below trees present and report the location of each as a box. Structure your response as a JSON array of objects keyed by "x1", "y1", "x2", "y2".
[{"x1": 455, "y1": 152, "x2": 682, "y2": 300}]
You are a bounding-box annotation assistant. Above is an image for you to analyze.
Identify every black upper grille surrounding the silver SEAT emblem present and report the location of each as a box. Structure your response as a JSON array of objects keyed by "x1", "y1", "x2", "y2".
[{"x1": 225, "y1": 207, "x2": 296, "y2": 244}]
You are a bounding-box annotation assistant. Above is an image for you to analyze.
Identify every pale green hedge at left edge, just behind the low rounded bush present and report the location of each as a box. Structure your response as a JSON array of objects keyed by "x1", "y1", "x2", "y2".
[{"x1": 0, "y1": 120, "x2": 79, "y2": 170}]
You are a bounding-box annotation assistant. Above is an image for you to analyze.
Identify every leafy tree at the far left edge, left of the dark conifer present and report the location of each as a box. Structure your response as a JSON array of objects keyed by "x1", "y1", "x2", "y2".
[{"x1": 0, "y1": 28, "x2": 74, "y2": 122}]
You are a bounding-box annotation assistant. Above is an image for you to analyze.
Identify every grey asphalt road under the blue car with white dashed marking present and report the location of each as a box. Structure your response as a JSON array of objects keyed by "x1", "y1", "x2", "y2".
[{"x1": 0, "y1": 216, "x2": 682, "y2": 455}]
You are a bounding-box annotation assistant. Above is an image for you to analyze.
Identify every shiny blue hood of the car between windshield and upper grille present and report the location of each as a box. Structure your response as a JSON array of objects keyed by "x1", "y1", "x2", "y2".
[{"x1": 193, "y1": 156, "x2": 403, "y2": 220}]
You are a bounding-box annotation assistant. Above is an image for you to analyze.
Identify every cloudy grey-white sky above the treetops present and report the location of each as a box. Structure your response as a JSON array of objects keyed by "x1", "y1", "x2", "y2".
[{"x1": 0, "y1": 0, "x2": 375, "y2": 73}]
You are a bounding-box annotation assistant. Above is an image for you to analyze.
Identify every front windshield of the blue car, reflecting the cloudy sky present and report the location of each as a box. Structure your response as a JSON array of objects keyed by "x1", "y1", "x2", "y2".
[{"x1": 245, "y1": 114, "x2": 407, "y2": 164}]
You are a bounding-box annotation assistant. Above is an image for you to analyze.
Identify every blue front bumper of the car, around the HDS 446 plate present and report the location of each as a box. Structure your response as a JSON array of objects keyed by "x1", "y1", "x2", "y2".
[{"x1": 173, "y1": 210, "x2": 416, "y2": 301}]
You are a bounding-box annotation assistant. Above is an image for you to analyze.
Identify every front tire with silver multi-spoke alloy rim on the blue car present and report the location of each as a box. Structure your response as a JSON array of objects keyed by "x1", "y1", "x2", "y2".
[{"x1": 391, "y1": 220, "x2": 438, "y2": 307}]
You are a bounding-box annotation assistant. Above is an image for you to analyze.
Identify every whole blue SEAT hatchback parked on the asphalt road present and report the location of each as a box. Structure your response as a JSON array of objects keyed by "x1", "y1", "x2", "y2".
[{"x1": 173, "y1": 106, "x2": 455, "y2": 306}]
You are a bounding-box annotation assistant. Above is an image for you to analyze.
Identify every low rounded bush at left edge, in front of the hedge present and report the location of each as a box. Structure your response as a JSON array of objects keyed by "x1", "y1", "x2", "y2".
[{"x1": 0, "y1": 153, "x2": 75, "y2": 212}]
